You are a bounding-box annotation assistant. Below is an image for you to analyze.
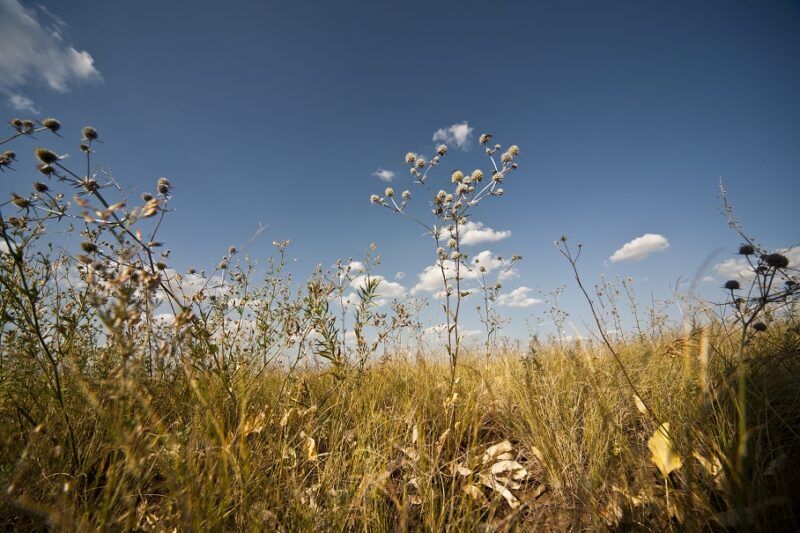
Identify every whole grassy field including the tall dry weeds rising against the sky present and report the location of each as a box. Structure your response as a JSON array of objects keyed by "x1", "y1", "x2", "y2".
[{"x1": 0, "y1": 119, "x2": 800, "y2": 532}]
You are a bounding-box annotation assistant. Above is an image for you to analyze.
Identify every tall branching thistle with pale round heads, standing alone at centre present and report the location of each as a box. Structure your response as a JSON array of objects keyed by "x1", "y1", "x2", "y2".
[{"x1": 370, "y1": 133, "x2": 519, "y2": 395}]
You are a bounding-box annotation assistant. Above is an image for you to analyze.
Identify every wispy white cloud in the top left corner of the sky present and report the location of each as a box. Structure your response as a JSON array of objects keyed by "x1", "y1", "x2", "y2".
[{"x1": 0, "y1": 0, "x2": 101, "y2": 111}]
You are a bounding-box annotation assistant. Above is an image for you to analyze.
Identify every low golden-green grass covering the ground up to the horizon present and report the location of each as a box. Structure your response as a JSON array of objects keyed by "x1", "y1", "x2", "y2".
[{"x1": 0, "y1": 322, "x2": 800, "y2": 531}]
